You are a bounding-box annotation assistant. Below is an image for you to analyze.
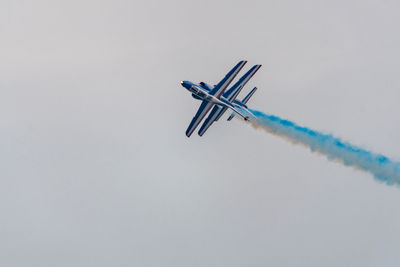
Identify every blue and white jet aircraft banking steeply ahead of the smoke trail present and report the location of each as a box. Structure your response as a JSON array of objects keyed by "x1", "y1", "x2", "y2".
[{"x1": 181, "y1": 60, "x2": 261, "y2": 137}]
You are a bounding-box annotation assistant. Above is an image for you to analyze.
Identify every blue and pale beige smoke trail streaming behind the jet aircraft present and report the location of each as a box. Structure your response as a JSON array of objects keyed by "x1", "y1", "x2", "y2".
[{"x1": 250, "y1": 110, "x2": 400, "y2": 185}]
